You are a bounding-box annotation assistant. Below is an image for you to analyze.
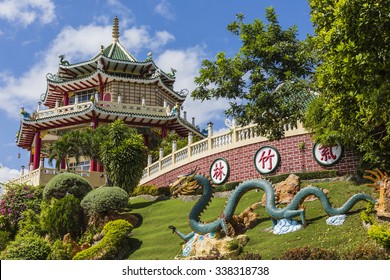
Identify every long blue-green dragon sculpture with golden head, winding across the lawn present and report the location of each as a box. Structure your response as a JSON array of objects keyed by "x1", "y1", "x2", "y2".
[{"x1": 169, "y1": 170, "x2": 375, "y2": 241}]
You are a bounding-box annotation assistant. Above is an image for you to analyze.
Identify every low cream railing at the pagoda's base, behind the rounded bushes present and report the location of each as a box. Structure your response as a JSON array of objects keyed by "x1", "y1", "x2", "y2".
[{"x1": 8, "y1": 167, "x2": 105, "y2": 187}]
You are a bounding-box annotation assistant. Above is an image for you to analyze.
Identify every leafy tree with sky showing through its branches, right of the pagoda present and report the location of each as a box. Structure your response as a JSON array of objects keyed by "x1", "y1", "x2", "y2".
[{"x1": 192, "y1": 7, "x2": 314, "y2": 139}]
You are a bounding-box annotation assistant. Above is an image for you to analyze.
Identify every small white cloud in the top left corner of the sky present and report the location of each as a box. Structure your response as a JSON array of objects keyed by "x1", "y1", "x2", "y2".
[{"x1": 0, "y1": 0, "x2": 56, "y2": 26}]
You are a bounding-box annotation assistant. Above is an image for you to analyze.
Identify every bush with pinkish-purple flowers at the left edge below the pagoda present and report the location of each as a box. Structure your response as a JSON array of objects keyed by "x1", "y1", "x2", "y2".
[{"x1": 0, "y1": 183, "x2": 42, "y2": 234}]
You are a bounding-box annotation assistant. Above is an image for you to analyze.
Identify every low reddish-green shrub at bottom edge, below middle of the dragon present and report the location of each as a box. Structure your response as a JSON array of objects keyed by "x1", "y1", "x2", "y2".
[{"x1": 280, "y1": 246, "x2": 340, "y2": 260}]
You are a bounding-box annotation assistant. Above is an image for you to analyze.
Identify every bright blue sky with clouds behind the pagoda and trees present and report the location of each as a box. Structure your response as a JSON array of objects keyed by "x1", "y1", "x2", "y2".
[{"x1": 0, "y1": 0, "x2": 313, "y2": 182}]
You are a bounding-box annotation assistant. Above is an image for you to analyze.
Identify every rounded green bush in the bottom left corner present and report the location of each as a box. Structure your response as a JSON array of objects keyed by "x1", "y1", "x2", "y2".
[{"x1": 0, "y1": 234, "x2": 50, "y2": 260}]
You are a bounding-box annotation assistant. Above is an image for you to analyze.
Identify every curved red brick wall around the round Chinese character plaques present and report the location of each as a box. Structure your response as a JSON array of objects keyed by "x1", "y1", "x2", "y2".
[{"x1": 143, "y1": 134, "x2": 358, "y2": 187}]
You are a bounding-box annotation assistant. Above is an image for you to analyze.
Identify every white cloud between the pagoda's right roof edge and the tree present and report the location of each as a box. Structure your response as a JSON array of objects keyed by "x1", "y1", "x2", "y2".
[{"x1": 156, "y1": 46, "x2": 229, "y2": 128}]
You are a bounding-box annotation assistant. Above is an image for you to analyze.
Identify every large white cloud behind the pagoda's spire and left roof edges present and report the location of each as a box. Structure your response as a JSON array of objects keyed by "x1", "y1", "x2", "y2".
[{"x1": 0, "y1": 24, "x2": 174, "y2": 117}]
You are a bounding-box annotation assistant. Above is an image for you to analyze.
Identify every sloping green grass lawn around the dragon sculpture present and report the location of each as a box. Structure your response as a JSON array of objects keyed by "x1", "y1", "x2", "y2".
[{"x1": 129, "y1": 181, "x2": 373, "y2": 260}]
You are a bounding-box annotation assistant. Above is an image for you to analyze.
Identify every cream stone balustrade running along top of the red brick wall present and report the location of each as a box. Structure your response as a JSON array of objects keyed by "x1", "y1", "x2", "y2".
[{"x1": 140, "y1": 123, "x2": 307, "y2": 185}]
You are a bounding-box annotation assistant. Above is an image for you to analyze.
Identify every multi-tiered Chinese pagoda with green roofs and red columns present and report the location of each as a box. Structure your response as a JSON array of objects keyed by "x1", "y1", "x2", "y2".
[{"x1": 16, "y1": 17, "x2": 204, "y2": 185}]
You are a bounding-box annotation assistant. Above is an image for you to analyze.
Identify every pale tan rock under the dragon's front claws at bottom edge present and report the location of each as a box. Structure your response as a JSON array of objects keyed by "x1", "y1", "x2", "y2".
[{"x1": 178, "y1": 233, "x2": 249, "y2": 259}]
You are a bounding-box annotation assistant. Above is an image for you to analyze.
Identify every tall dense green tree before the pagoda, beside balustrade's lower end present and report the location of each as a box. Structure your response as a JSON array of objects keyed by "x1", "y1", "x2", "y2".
[{"x1": 100, "y1": 120, "x2": 147, "y2": 193}]
